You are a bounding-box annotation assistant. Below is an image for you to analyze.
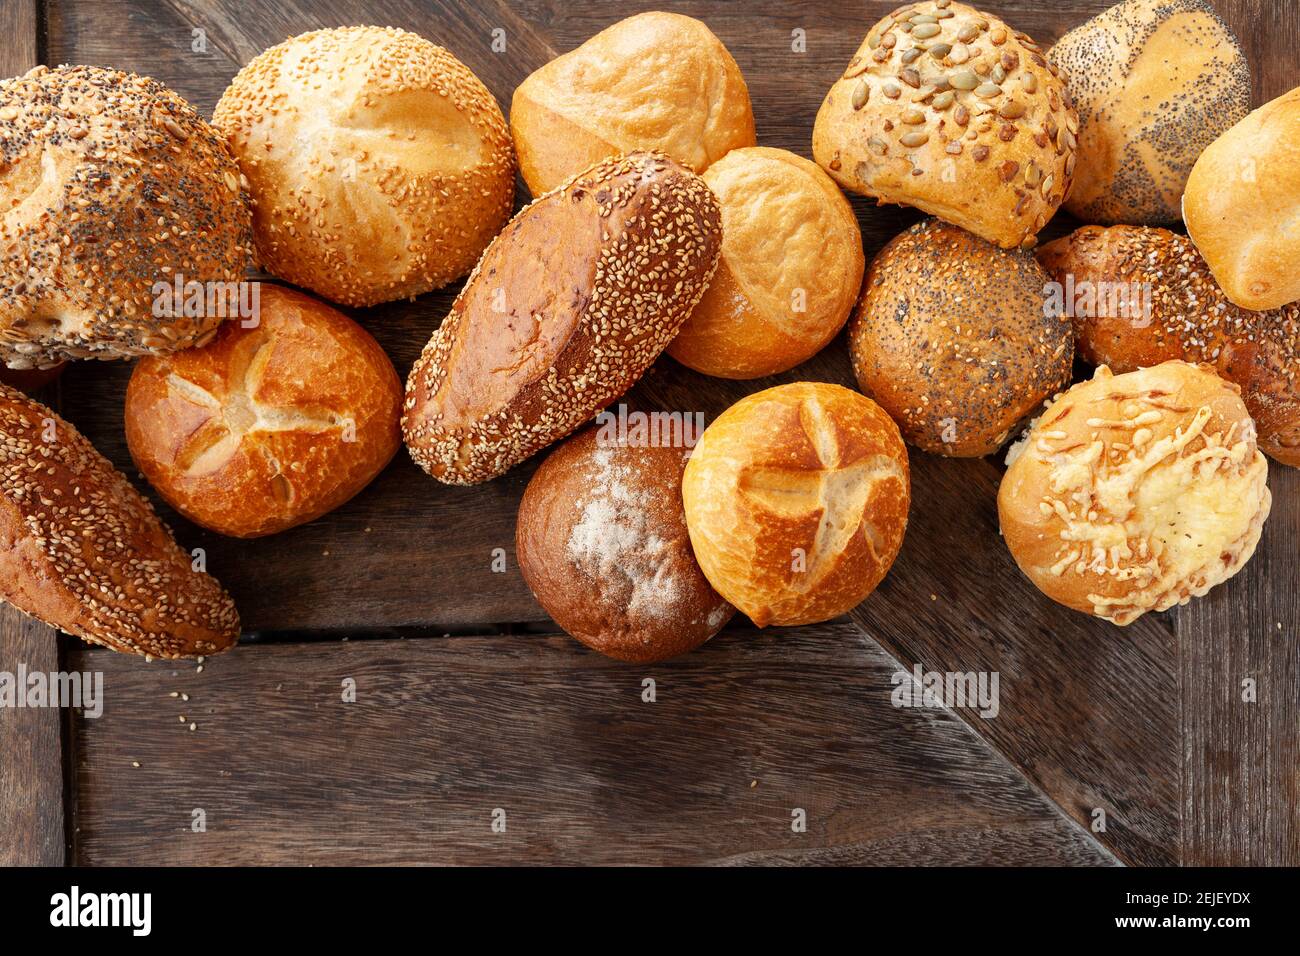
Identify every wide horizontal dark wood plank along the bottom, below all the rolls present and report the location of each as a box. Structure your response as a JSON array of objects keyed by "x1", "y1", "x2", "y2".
[{"x1": 65, "y1": 623, "x2": 1114, "y2": 865}]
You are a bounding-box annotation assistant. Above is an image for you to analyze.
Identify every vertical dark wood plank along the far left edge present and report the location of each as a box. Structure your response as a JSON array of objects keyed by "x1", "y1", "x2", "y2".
[{"x1": 0, "y1": 0, "x2": 64, "y2": 866}]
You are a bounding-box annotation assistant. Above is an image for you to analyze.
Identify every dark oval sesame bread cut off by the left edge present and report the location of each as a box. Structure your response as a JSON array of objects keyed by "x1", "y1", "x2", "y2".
[{"x1": 0, "y1": 385, "x2": 239, "y2": 658}]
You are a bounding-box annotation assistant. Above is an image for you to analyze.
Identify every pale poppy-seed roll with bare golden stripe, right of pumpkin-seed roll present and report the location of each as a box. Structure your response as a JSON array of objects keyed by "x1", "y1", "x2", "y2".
[{"x1": 1048, "y1": 0, "x2": 1251, "y2": 225}]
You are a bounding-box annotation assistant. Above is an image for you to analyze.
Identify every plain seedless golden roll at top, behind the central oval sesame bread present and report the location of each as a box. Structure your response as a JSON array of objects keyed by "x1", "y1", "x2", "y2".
[{"x1": 510, "y1": 13, "x2": 755, "y2": 196}]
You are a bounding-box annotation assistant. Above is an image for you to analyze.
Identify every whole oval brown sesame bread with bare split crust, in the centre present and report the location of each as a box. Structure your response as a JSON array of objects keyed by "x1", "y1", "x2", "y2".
[{"x1": 402, "y1": 153, "x2": 722, "y2": 484}]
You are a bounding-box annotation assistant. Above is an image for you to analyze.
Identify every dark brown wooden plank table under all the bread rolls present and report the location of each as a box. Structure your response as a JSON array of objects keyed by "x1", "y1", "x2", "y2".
[{"x1": 0, "y1": 0, "x2": 1300, "y2": 865}]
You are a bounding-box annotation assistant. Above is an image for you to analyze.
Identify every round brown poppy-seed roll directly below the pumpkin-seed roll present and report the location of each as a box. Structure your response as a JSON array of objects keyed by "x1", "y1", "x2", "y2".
[{"x1": 849, "y1": 220, "x2": 1074, "y2": 458}]
